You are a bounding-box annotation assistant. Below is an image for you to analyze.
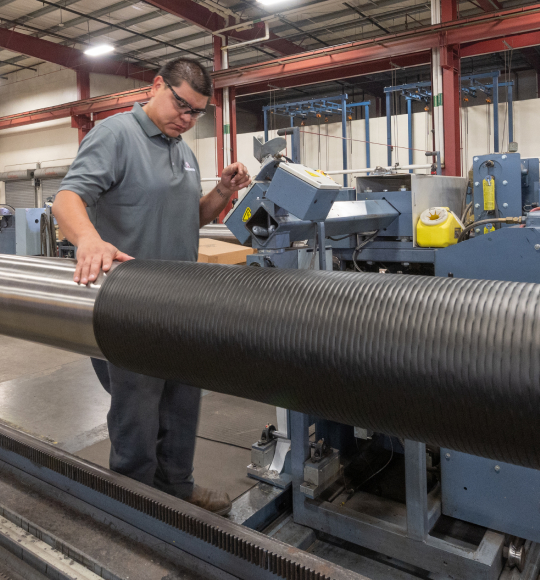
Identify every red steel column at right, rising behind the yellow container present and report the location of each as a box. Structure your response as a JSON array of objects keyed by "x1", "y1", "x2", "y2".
[{"x1": 441, "y1": 0, "x2": 461, "y2": 175}]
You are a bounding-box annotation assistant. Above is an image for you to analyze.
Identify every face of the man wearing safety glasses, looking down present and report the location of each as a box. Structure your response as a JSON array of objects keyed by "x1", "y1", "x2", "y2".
[{"x1": 150, "y1": 76, "x2": 208, "y2": 138}]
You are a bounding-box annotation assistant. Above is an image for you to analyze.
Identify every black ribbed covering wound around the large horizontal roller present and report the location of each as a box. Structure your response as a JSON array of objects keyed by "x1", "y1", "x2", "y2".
[{"x1": 94, "y1": 260, "x2": 540, "y2": 468}]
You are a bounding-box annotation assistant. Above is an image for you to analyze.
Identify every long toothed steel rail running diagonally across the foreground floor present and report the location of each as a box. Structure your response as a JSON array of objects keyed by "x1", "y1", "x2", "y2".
[{"x1": 0, "y1": 424, "x2": 369, "y2": 580}]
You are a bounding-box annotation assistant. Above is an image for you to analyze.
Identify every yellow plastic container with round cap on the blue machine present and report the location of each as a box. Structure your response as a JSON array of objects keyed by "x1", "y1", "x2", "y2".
[{"x1": 416, "y1": 207, "x2": 464, "y2": 248}]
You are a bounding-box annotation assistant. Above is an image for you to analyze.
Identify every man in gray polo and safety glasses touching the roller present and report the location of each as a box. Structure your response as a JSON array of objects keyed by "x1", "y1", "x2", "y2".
[{"x1": 53, "y1": 59, "x2": 251, "y2": 515}]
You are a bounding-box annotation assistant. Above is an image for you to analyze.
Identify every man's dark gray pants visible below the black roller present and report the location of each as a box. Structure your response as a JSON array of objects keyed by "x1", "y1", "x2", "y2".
[{"x1": 92, "y1": 359, "x2": 201, "y2": 498}]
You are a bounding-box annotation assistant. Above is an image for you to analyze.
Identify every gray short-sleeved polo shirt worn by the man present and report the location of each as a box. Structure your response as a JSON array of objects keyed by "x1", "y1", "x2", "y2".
[{"x1": 59, "y1": 104, "x2": 202, "y2": 261}]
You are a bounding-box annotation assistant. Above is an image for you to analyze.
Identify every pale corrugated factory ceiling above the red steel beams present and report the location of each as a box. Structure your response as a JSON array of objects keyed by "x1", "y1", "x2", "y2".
[{"x1": 0, "y1": 0, "x2": 540, "y2": 102}]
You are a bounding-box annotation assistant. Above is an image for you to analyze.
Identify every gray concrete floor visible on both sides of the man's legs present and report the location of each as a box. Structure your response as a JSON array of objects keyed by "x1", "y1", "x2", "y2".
[{"x1": 0, "y1": 336, "x2": 260, "y2": 499}]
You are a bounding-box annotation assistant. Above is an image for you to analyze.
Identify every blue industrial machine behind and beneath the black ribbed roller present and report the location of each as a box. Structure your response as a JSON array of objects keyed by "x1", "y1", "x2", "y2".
[{"x1": 226, "y1": 138, "x2": 540, "y2": 579}]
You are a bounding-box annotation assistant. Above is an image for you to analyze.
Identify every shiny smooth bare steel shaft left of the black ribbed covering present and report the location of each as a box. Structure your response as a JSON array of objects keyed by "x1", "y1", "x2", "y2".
[{"x1": 0, "y1": 254, "x2": 105, "y2": 358}]
